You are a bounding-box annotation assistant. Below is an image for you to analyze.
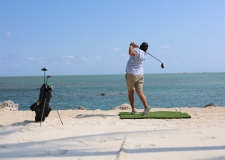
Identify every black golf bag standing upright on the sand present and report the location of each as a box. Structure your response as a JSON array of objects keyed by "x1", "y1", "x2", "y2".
[{"x1": 30, "y1": 84, "x2": 52, "y2": 122}]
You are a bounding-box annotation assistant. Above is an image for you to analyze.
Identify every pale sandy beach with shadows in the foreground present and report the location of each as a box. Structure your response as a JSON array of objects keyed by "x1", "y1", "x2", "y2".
[{"x1": 0, "y1": 107, "x2": 225, "y2": 160}]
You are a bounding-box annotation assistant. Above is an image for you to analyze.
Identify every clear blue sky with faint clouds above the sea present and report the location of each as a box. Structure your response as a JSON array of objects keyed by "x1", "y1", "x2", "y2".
[{"x1": 0, "y1": 0, "x2": 225, "y2": 76}]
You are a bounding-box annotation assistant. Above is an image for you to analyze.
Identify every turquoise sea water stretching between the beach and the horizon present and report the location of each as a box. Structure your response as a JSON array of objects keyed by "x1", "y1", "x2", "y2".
[{"x1": 0, "y1": 73, "x2": 225, "y2": 110}]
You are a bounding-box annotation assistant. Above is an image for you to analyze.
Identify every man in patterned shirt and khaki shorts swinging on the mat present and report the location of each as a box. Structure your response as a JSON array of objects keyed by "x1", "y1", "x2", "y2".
[{"x1": 125, "y1": 42, "x2": 151, "y2": 116}]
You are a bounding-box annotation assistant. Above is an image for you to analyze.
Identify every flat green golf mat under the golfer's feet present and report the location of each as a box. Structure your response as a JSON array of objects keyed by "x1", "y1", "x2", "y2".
[{"x1": 119, "y1": 111, "x2": 191, "y2": 119}]
